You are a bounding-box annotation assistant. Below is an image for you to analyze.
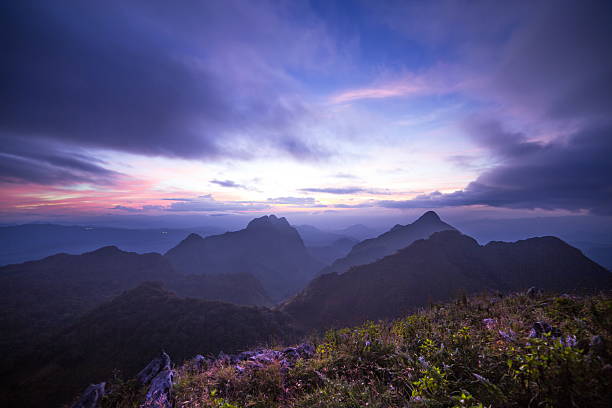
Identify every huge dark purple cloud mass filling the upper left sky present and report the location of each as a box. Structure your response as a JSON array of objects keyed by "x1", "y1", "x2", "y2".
[{"x1": 0, "y1": 0, "x2": 332, "y2": 165}]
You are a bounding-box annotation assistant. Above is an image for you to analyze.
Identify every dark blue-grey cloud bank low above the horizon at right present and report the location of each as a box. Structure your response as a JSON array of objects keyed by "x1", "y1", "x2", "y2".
[{"x1": 379, "y1": 118, "x2": 612, "y2": 215}]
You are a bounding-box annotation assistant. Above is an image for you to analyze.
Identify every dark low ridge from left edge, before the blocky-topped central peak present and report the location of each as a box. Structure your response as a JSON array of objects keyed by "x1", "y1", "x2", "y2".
[{"x1": 0, "y1": 247, "x2": 271, "y2": 380}]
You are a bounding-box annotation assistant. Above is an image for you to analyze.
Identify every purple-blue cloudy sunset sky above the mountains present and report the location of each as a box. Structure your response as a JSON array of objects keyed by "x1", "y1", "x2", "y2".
[{"x1": 0, "y1": 0, "x2": 612, "y2": 230}]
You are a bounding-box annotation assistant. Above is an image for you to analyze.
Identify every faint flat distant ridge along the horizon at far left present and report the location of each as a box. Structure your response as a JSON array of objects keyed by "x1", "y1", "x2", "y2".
[{"x1": 0, "y1": 224, "x2": 223, "y2": 265}]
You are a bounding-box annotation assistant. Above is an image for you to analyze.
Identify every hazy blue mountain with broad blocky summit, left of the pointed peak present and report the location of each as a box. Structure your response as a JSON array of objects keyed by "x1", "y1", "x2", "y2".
[{"x1": 165, "y1": 215, "x2": 322, "y2": 301}]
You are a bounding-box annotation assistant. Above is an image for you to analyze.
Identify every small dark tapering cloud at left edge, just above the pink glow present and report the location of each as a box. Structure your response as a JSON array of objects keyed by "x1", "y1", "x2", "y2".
[{"x1": 0, "y1": 137, "x2": 120, "y2": 185}]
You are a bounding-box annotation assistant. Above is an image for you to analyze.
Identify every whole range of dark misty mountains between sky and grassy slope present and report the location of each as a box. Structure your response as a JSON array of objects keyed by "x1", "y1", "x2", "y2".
[{"x1": 0, "y1": 211, "x2": 612, "y2": 407}]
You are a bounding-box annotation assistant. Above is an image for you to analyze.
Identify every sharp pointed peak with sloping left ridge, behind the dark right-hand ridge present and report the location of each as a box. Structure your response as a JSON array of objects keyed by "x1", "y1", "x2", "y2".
[{"x1": 321, "y1": 211, "x2": 455, "y2": 274}]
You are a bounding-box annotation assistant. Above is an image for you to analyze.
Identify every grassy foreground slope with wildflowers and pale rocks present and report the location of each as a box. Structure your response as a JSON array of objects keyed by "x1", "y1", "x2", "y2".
[{"x1": 103, "y1": 294, "x2": 612, "y2": 408}]
